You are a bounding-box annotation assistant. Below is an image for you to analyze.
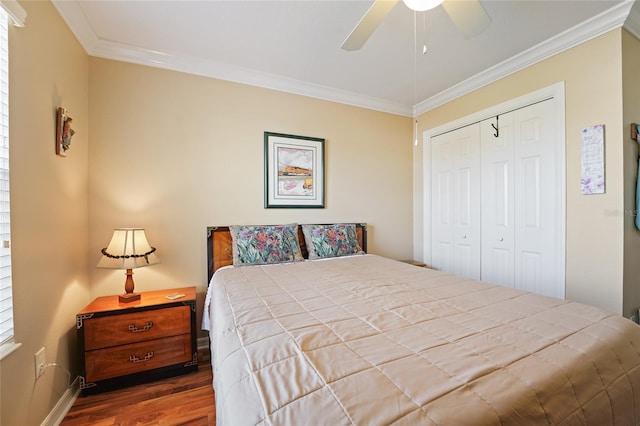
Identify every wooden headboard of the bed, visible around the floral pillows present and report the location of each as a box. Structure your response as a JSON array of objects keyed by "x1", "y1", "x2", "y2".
[{"x1": 207, "y1": 223, "x2": 367, "y2": 282}]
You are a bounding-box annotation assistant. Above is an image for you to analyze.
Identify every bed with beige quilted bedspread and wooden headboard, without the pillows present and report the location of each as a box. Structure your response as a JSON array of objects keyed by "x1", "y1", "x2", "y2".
[{"x1": 203, "y1": 226, "x2": 640, "y2": 425}]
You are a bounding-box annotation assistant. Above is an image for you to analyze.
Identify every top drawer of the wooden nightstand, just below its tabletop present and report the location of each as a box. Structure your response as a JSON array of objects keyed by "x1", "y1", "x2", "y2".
[{"x1": 84, "y1": 306, "x2": 191, "y2": 351}]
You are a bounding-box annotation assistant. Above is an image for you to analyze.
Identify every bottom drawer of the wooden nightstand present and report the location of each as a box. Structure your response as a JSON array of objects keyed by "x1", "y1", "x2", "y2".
[{"x1": 85, "y1": 334, "x2": 193, "y2": 382}]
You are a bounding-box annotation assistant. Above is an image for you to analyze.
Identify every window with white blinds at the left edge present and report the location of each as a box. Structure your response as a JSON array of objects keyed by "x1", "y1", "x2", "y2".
[{"x1": 0, "y1": 0, "x2": 26, "y2": 359}]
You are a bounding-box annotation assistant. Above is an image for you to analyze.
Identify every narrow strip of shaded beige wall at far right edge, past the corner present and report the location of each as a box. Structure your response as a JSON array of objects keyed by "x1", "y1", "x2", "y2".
[{"x1": 622, "y1": 31, "x2": 640, "y2": 316}]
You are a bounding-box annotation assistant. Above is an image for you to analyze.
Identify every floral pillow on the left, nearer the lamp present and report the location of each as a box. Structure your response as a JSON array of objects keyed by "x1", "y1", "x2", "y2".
[{"x1": 229, "y1": 224, "x2": 304, "y2": 266}]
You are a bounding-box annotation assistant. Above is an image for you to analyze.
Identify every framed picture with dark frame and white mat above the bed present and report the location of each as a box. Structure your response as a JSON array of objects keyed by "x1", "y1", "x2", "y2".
[{"x1": 264, "y1": 132, "x2": 324, "y2": 209}]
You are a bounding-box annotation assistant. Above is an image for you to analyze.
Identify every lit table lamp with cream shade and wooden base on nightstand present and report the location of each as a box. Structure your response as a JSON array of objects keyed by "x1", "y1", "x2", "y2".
[{"x1": 97, "y1": 228, "x2": 160, "y2": 303}]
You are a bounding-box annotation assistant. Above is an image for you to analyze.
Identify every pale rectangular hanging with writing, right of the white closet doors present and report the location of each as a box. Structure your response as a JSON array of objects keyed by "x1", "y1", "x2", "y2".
[{"x1": 581, "y1": 124, "x2": 605, "y2": 195}]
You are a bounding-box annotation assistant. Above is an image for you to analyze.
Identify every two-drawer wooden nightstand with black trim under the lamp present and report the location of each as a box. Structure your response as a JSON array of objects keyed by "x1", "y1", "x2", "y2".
[{"x1": 76, "y1": 287, "x2": 198, "y2": 394}]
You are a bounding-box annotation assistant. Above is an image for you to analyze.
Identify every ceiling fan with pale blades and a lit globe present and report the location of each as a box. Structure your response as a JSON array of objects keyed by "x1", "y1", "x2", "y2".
[{"x1": 341, "y1": 0, "x2": 491, "y2": 51}]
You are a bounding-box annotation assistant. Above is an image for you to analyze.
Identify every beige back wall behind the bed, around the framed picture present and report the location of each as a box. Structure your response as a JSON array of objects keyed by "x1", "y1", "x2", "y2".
[{"x1": 89, "y1": 58, "x2": 412, "y2": 330}]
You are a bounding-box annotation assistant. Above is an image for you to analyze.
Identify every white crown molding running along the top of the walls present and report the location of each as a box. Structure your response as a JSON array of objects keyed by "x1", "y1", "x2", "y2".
[{"x1": 52, "y1": 0, "x2": 640, "y2": 117}]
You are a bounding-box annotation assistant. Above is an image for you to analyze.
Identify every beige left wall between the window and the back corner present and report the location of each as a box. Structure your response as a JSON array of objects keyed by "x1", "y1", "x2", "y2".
[{"x1": 0, "y1": 2, "x2": 90, "y2": 426}]
